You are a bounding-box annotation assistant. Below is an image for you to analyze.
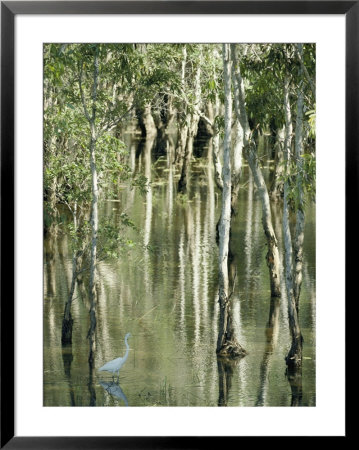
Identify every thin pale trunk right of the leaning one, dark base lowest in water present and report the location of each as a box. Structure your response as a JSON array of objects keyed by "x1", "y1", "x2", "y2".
[{"x1": 283, "y1": 78, "x2": 302, "y2": 368}]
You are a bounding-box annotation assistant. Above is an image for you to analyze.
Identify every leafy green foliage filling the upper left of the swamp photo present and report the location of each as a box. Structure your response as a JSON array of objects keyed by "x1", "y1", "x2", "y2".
[{"x1": 44, "y1": 44, "x2": 167, "y2": 268}]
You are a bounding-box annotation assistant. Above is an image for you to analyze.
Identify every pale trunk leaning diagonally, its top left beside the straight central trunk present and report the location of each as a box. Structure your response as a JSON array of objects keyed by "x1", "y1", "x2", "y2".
[{"x1": 232, "y1": 45, "x2": 280, "y2": 297}]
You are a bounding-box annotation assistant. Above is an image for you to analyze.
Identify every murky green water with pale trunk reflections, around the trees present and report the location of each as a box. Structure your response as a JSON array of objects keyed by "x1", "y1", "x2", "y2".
[{"x1": 43, "y1": 135, "x2": 316, "y2": 406}]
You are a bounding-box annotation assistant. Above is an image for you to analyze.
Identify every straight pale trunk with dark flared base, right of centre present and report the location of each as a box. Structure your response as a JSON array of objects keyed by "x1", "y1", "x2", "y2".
[{"x1": 217, "y1": 44, "x2": 245, "y2": 357}]
